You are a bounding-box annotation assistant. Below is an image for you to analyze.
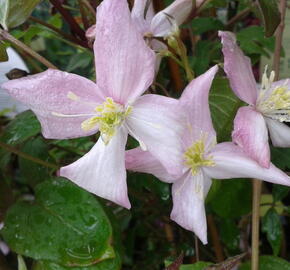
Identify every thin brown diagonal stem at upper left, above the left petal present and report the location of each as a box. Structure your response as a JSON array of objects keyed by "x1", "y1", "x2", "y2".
[{"x1": 0, "y1": 29, "x2": 57, "y2": 69}]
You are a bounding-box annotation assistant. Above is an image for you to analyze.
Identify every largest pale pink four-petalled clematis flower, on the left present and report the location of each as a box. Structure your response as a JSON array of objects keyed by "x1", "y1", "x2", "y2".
[{"x1": 3, "y1": 0, "x2": 183, "y2": 208}]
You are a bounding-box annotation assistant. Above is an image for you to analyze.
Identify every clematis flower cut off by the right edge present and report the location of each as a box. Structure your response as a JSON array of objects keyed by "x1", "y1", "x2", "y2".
[{"x1": 219, "y1": 31, "x2": 290, "y2": 168}]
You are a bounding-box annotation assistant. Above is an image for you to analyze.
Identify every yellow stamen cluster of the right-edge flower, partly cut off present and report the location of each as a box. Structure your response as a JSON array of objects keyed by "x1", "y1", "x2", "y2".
[{"x1": 257, "y1": 68, "x2": 290, "y2": 122}]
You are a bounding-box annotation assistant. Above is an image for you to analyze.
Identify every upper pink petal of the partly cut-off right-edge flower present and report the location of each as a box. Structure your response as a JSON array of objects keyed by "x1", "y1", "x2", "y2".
[{"x1": 219, "y1": 31, "x2": 258, "y2": 105}]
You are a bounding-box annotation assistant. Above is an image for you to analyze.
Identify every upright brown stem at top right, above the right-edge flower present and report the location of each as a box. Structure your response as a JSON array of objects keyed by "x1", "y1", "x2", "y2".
[{"x1": 273, "y1": 0, "x2": 287, "y2": 80}]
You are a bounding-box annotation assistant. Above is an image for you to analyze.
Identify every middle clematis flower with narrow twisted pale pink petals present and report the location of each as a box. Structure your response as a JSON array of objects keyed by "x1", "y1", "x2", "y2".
[{"x1": 126, "y1": 66, "x2": 290, "y2": 244}]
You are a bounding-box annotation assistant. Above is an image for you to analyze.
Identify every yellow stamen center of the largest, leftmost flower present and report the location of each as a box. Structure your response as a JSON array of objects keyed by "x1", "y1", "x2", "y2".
[{"x1": 82, "y1": 97, "x2": 132, "y2": 144}]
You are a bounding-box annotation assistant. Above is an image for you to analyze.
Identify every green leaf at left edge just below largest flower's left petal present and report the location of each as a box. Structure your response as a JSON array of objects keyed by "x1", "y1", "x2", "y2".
[{"x1": 0, "y1": 111, "x2": 40, "y2": 145}]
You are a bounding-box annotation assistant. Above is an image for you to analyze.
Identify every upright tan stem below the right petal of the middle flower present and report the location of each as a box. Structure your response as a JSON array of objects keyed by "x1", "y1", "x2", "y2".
[{"x1": 251, "y1": 179, "x2": 262, "y2": 270}]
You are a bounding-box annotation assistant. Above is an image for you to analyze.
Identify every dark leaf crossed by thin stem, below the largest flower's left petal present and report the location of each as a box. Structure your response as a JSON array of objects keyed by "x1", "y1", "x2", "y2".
[{"x1": 19, "y1": 137, "x2": 52, "y2": 187}]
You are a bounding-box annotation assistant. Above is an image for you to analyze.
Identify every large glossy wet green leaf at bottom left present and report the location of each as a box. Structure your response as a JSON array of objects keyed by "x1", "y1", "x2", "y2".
[{"x1": 1, "y1": 178, "x2": 115, "y2": 266}]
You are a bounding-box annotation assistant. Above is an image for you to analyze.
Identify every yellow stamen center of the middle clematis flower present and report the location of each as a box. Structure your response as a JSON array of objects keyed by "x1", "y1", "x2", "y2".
[{"x1": 183, "y1": 138, "x2": 215, "y2": 175}]
